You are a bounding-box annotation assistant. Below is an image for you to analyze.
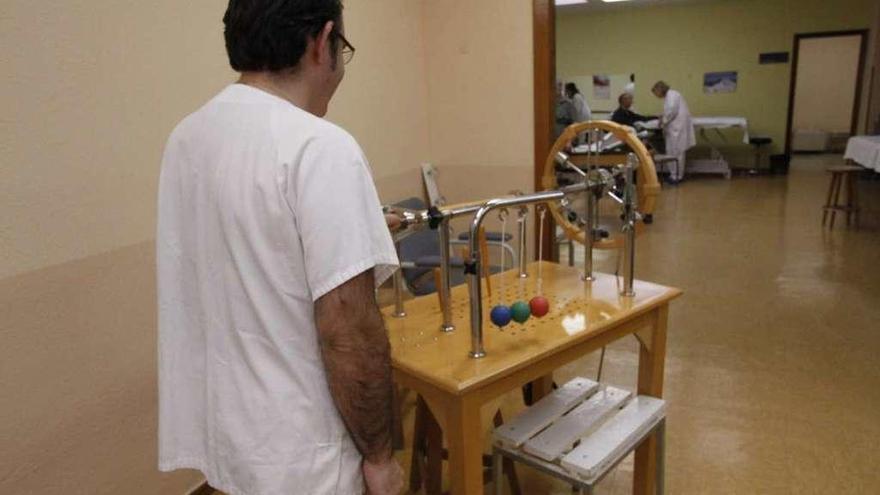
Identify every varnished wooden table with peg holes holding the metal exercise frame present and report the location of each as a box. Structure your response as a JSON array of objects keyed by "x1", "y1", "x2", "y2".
[{"x1": 384, "y1": 262, "x2": 681, "y2": 495}]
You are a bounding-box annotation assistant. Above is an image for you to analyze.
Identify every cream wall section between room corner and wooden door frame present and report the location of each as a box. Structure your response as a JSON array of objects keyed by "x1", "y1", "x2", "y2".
[{"x1": 424, "y1": 0, "x2": 534, "y2": 185}]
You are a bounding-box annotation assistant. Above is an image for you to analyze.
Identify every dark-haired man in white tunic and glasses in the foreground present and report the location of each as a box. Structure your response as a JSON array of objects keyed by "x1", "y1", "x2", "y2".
[{"x1": 157, "y1": 0, "x2": 402, "y2": 495}]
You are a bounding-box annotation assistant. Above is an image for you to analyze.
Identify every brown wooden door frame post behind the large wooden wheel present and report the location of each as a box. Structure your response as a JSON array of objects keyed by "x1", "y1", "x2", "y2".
[{"x1": 532, "y1": 0, "x2": 556, "y2": 260}]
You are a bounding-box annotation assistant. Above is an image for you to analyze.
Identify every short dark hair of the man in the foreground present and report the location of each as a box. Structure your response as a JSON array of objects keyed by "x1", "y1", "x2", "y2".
[{"x1": 223, "y1": 0, "x2": 342, "y2": 72}]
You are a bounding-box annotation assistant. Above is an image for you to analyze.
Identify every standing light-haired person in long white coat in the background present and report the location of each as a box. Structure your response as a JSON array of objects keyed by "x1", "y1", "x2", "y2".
[{"x1": 651, "y1": 81, "x2": 697, "y2": 182}]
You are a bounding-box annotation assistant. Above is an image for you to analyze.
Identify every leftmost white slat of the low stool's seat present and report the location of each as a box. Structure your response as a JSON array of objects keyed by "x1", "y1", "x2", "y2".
[{"x1": 494, "y1": 378, "x2": 599, "y2": 448}]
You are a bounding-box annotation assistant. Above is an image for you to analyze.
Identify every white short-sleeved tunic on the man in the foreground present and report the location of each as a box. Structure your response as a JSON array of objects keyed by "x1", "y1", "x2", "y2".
[{"x1": 157, "y1": 84, "x2": 398, "y2": 495}]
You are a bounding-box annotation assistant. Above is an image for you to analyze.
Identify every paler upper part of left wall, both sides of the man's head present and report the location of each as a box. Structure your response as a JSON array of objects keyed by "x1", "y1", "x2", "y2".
[{"x1": 0, "y1": 0, "x2": 428, "y2": 278}]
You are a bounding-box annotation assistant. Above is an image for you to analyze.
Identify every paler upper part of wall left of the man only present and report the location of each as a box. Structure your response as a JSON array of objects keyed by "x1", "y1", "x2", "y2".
[{"x1": 0, "y1": 0, "x2": 231, "y2": 278}]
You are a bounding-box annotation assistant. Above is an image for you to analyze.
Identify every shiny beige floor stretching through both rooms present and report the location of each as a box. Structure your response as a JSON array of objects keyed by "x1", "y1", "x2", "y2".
[{"x1": 220, "y1": 156, "x2": 880, "y2": 495}]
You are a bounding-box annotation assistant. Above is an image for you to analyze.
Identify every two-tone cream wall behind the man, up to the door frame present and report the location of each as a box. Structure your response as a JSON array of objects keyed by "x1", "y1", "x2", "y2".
[{"x1": 0, "y1": 0, "x2": 532, "y2": 495}]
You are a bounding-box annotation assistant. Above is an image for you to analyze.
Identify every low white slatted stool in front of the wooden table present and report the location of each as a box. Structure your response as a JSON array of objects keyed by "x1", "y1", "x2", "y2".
[{"x1": 493, "y1": 378, "x2": 666, "y2": 495}]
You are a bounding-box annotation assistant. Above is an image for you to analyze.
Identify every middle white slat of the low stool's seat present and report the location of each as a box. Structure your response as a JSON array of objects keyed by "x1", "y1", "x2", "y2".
[{"x1": 523, "y1": 387, "x2": 630, "y2": 462}]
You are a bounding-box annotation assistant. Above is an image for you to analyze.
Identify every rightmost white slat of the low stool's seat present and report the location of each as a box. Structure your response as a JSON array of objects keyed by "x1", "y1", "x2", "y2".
[{"x1": 561, "y1": 396, "x2": 666, "y2": 480}]
